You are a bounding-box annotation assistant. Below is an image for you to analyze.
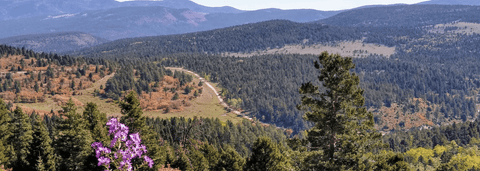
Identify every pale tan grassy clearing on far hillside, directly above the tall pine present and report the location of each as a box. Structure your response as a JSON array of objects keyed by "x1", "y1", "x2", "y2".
[{"x1": 222, "y1": 40, "x2": 395, "y2": 57}]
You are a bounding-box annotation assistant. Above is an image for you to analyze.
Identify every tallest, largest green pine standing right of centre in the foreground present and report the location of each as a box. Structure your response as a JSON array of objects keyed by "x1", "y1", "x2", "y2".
[{"x1": 297, "y1": 52, "x2": 381, "y2": 170}]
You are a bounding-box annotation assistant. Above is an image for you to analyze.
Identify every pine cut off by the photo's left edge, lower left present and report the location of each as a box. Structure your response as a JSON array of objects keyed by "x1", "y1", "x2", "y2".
[{"x1": 0, "y1": 99, "x2": 13, "y2": 166}]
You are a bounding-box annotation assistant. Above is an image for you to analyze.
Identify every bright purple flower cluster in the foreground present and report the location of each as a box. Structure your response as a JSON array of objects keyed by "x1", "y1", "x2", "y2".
[{"x1": 92, "y1": 118, "x2": 153, "y2": 171}]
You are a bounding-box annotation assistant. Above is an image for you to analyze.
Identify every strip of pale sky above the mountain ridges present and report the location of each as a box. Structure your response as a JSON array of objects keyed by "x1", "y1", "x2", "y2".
[{"x1": 117, "y1": 0, "x2": 432, "y2": 11}]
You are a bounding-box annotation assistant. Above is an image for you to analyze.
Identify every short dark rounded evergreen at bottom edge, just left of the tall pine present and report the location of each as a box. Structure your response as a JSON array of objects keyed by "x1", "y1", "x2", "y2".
[{"x1": 244, "y1": 137, "x2": 292, "y2": 171}]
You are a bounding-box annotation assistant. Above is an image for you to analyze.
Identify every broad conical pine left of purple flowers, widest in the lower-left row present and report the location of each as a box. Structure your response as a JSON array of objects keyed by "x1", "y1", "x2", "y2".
[{"x1": 54, "y1": 99, "x2": 93, "y2": 170}]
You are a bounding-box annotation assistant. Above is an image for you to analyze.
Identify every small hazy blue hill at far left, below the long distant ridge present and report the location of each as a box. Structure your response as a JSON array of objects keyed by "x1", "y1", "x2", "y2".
[{"x1": 0, "y1": 32, "x2": 108, "y2": 53}]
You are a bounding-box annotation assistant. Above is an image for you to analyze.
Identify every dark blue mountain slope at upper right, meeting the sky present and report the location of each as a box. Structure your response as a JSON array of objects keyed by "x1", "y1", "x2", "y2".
[{"x1": 316, "y1": 5, "x2": 480, "y2": 27}]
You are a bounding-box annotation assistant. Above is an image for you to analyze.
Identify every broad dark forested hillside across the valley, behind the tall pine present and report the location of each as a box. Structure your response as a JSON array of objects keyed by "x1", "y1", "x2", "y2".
[{"x1": 66, "y1": 14, "x2": 480, "y2": 132}]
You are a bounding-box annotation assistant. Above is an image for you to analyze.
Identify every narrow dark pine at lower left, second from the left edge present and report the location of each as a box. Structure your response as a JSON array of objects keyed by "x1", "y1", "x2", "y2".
[{"x1": 7, "y1": 107, "x2": 34, "y2": 170}]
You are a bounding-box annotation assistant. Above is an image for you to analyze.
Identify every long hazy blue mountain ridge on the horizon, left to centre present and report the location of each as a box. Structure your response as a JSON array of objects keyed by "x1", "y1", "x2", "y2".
[{"x1": 0, "y1": 6, "x2": 336, "y2": 40}]
